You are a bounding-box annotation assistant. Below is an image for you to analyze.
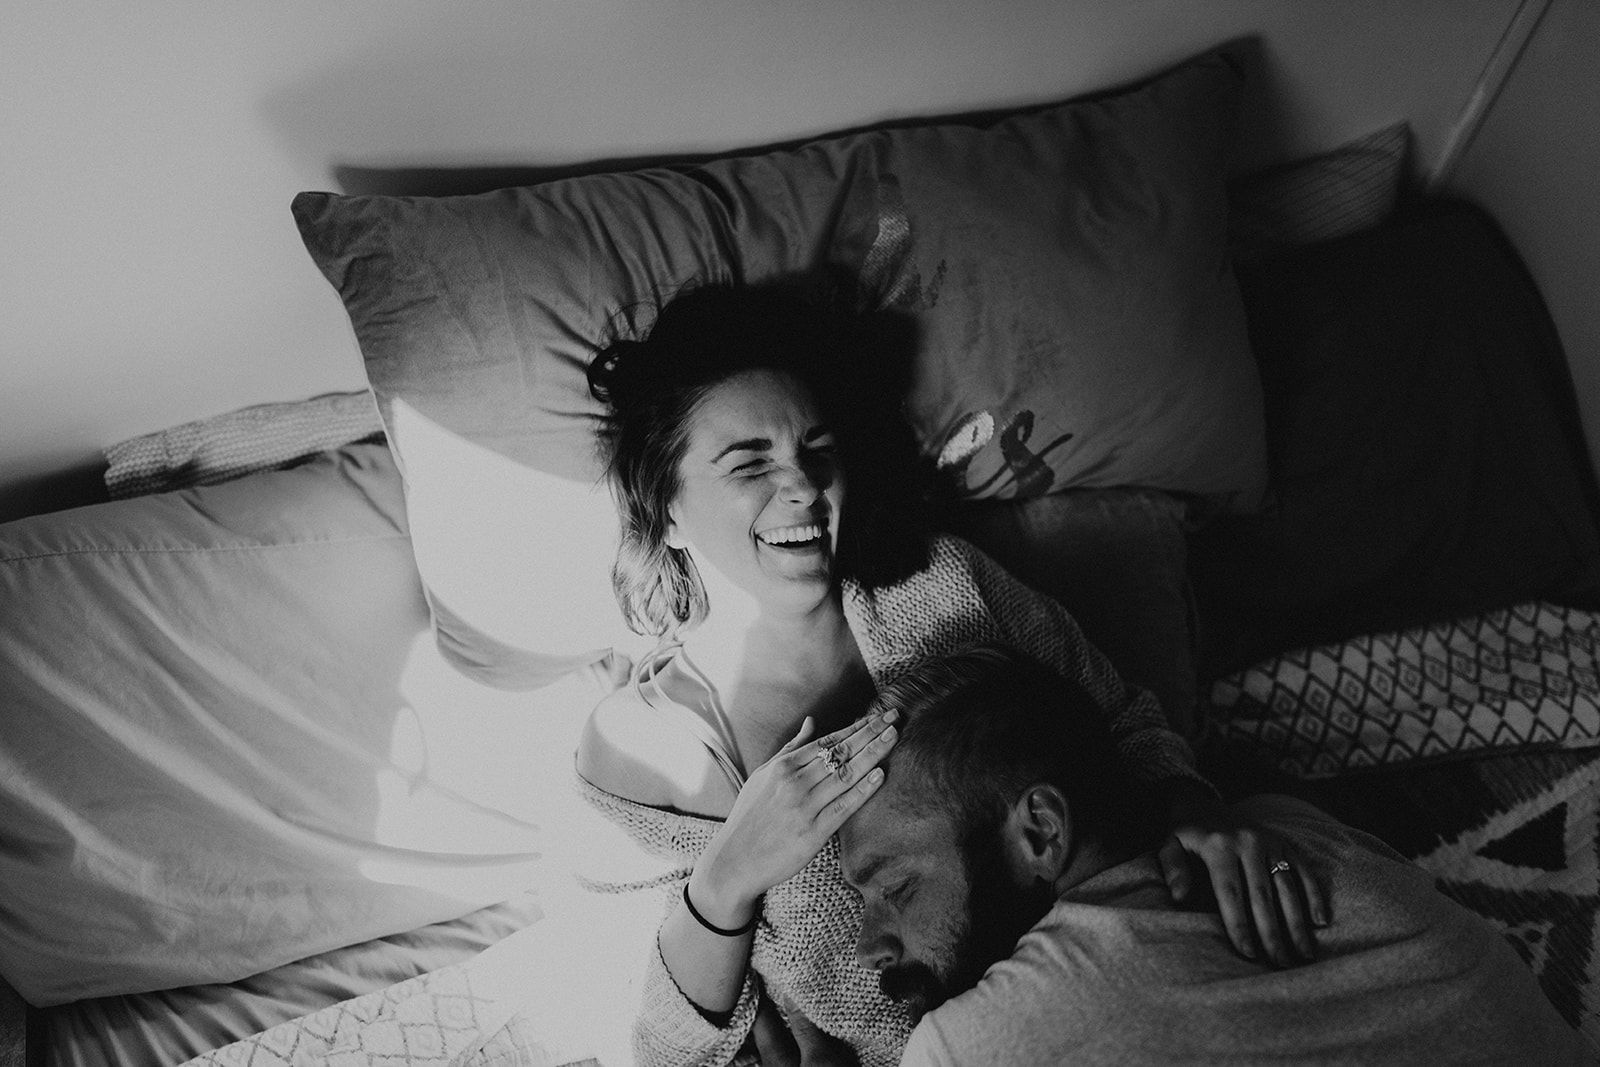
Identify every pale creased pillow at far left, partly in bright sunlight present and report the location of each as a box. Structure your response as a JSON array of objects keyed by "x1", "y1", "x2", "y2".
[{"x1": 0, "y1": 443, "x2": 579, "y2": 1006}]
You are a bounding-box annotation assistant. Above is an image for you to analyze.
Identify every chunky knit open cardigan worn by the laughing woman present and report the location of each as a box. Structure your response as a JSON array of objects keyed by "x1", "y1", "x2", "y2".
[{"x1": 579, "y1": 537, "x2": 1195, "y2": 1067}]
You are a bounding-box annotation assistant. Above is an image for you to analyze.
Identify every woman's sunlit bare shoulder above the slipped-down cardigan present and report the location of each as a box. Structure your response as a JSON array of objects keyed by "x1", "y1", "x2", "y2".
[{"x1": 576, "y1": 686, "x2": 726, "y2": 811}]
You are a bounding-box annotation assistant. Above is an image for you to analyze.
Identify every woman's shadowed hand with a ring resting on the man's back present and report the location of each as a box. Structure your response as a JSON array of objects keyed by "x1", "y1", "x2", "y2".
[{"x1": 1160, "y1": 784, "x2": 1330, "y2": 966}]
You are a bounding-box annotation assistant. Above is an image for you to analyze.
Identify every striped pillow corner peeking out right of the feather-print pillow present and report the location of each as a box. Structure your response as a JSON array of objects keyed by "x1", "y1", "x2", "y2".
[{"x1": 1227, "y1": 122, "x2": 1411, "y2": 262}]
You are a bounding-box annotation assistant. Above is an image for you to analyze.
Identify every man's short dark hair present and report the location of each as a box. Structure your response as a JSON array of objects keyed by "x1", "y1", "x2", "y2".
[{"x1": 874, "y1": 643, "x2": 1165, "y2": 849}]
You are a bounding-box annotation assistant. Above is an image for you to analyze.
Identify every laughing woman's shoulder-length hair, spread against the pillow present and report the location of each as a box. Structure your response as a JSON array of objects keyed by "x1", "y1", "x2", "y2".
[{"x1": 589, "y1": 277, "x2": 922, "y2": 635}]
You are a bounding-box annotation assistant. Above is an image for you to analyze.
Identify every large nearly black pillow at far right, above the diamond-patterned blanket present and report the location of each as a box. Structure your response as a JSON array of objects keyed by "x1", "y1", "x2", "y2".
[{"x1": 1189, "y1": 202, "x2": 1600, "y2": 675}]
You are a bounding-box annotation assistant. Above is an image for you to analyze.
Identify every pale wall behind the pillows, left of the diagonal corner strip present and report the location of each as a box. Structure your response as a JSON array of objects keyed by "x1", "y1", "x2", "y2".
[{"x1": 0, "y1": 0, "x2": 1516, "y2": 518}]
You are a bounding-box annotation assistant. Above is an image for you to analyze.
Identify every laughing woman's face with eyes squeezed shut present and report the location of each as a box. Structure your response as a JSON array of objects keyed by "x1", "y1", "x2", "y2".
[{"x1": 667, "y1": 370, "x2": 845, "y2": 609}]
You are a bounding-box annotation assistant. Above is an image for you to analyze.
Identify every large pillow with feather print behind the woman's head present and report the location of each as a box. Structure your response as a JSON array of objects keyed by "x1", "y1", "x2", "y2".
[{"x1": 294, "y1": 47, "x2": 1266, "y2": 686}]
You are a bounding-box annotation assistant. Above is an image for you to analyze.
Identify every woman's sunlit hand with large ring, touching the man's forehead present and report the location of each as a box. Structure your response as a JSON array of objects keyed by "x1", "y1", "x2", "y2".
[{"x1": 690, "y1": 710, "x2": 898, "y2": 929}]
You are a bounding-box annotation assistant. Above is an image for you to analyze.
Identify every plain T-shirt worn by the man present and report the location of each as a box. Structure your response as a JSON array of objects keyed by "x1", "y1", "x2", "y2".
[{"x1": 904, "y1": 797, "x2": 1589, "y2": 1067}]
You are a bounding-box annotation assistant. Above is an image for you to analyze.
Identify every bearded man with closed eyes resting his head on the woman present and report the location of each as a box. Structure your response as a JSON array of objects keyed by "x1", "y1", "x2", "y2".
[{"x1": 840, "y1": 648, "x2": 1594, "y2": 1067}]
